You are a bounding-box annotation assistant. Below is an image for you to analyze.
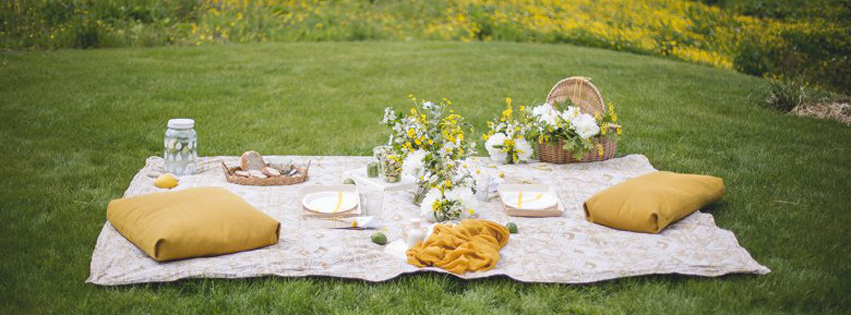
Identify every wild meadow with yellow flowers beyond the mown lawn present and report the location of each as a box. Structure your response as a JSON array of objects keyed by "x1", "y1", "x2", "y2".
[{"x1": 0, "y1": 0, "x2": 851, "y2": 95}]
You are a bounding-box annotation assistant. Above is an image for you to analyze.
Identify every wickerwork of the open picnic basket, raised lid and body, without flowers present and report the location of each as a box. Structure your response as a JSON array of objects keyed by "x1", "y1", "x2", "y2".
[{"x1": 538, "y1": 77, "x2": 618, "y2": 164}]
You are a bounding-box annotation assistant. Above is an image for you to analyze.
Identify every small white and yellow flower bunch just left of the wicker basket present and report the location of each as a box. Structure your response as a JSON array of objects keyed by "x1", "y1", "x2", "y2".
[{"x1": 483, "y1": 98, "x2": 534, "y2": 164}]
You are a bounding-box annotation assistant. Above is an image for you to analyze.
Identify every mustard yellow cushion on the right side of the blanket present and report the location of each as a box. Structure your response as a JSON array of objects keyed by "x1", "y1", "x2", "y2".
[{"x1": 585, "y1": 172, "x2": 724, "y2": 233}]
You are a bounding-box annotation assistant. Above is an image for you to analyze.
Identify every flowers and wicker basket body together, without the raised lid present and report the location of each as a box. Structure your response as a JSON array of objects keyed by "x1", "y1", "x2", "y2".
[{"x1": 526, "y1": 99, "x2": 623, "y2": 163}]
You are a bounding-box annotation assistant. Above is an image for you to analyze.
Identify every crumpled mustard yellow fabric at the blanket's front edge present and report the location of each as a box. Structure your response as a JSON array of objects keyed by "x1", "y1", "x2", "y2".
[{"x1": 407, "y1": 220, "x2": 509, "y2": 274}]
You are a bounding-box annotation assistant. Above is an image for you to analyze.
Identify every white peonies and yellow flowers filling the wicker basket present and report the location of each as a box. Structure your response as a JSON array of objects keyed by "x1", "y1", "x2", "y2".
[{"x1": 527, "y1": 99, "x2": 623, "y2": 160}]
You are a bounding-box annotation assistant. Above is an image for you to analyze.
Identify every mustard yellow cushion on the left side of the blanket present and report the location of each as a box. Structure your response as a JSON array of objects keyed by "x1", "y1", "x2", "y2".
[{"x1": 106, "y1": 187, "x2": 281, "y2": 261}]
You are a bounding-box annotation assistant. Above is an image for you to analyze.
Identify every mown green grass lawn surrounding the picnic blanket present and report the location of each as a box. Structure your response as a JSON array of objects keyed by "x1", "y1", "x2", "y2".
[{"x1": 0, "y1": 42, "x2": 851, "y2": 314}]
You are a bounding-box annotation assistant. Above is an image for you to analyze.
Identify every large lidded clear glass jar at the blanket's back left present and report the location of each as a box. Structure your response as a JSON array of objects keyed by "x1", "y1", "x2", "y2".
[{"x1": 163, "y1": 118, "x2": 198, "y2": 175}]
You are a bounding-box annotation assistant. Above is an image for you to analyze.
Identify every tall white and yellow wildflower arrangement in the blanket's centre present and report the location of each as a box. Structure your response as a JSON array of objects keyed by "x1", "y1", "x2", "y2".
[{"x1": 381, "y1": 95, "x2": 476, "y2": 221}]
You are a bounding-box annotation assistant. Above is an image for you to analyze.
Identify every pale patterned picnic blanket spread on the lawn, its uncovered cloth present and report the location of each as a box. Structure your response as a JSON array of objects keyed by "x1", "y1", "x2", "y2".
[{"x1": 86, "y1": 155, "x2": 770, "y2": 285}]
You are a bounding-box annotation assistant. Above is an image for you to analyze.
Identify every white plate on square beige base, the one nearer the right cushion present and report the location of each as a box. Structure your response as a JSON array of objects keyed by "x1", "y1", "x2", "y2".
[{"x1": 498, "y1": 184, "x2": 564, "y2": 217}]
